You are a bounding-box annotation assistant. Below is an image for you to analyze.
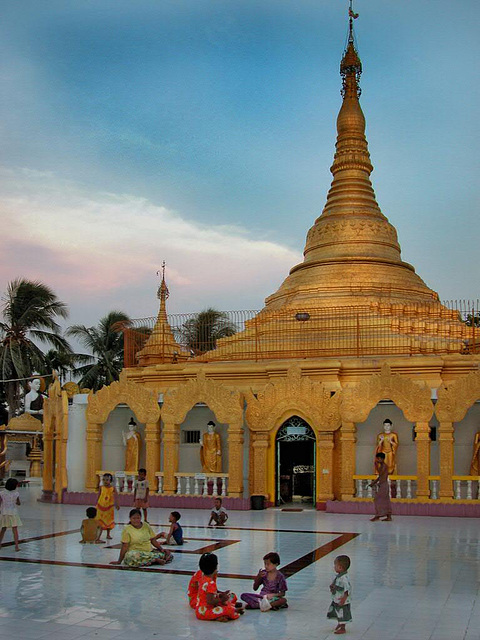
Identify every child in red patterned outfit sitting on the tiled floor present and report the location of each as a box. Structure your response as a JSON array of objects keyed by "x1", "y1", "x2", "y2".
[{"x1": 195, "y1": 553, "x2": 243, "y2": 622}]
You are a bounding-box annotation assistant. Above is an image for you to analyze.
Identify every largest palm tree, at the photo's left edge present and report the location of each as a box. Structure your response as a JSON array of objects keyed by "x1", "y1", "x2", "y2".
[{"x1": 0, "y1": 278, "x2": 71, "y2": 418}]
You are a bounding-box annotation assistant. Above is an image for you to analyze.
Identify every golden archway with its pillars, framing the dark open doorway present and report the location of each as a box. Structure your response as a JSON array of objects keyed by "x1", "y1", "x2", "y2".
[{"x1": 245, "y1": 363, "x2": 341, "y2": 501}]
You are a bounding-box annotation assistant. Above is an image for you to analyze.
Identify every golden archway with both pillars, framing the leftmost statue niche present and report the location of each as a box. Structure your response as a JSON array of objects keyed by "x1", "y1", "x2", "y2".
[{"x1": 85, "y1": 371, "x2": 160, "y2": 491}]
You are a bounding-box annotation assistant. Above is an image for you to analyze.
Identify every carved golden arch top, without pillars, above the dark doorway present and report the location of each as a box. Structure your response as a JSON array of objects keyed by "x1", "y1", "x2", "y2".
[{"x1": 246, "y1": 363, "x2": 341, "y2": 433}]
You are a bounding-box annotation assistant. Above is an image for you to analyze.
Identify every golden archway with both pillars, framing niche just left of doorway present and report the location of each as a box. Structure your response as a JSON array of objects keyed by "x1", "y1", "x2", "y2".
[{"x1": 162, "y1": 370, "x2": 243, "y2": 497}]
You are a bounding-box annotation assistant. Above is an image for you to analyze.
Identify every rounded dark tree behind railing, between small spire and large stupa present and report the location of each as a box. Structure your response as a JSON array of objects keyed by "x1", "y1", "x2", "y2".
[{"x1": 179, "y1": 307, "x2": 237, "y2": 355}]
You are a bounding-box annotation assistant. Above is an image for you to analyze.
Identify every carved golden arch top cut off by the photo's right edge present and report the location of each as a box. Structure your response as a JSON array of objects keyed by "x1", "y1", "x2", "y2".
[{"x1": 435, "y1": 371, "x2": 480, "y2": 422}]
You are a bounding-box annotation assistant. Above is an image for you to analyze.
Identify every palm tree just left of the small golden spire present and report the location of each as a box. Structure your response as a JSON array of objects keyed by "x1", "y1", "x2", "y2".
[{"x1": 67, "y1": 311, "x2": 130, "y2": 391}]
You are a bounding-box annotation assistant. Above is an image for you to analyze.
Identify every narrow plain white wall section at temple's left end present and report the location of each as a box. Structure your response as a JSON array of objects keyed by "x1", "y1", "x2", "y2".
[{"x1": 67, "y1": 393, "x2": 88, "y2": 491}]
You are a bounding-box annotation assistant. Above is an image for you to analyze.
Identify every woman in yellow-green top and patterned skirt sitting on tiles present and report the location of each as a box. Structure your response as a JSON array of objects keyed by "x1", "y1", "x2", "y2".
[{"x1": 110, "y1": 509, "x2": 173, "y2": 567}]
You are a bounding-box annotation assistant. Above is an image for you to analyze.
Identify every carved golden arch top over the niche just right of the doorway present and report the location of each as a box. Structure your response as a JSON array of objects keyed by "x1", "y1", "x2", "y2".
[{"x1": 340, "y1": 363, "x2": 434, "y2": 422}]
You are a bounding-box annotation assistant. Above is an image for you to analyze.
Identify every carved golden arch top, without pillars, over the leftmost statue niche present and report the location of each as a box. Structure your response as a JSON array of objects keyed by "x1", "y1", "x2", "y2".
[{"x1": 86, "y1": 372, "x2": 160, "y2": 424}]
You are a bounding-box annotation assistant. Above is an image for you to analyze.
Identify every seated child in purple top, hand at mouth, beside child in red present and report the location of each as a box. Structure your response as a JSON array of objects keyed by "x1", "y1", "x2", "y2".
[{"x1": 240, "y1": 552, "x2": 288, "y2": 611}]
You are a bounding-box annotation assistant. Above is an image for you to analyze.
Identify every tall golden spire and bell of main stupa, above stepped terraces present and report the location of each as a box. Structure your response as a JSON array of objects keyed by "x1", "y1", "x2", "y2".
[{"x1": 266, "y1": 0, "x2": 438, "y2": 309}]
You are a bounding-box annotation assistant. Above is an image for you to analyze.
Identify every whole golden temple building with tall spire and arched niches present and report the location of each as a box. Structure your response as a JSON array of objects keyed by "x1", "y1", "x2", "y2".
[{"x1": 36, "y1": 17, "x2": 480, "y2": 515}]
